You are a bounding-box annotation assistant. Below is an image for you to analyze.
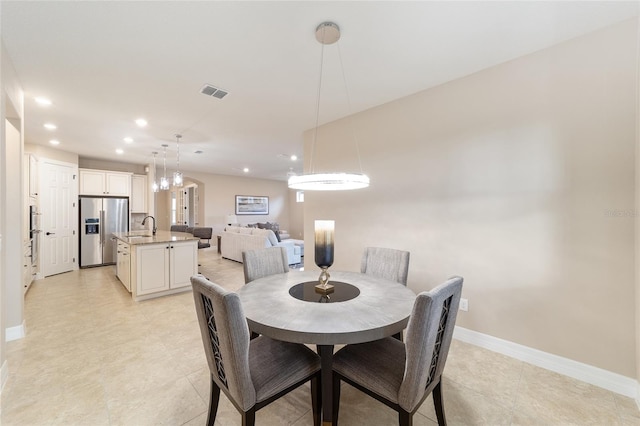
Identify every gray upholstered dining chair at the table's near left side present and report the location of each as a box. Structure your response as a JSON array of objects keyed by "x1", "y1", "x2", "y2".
[{"x1": 191, "y1": 275, "x2": 322, "y2": 426}]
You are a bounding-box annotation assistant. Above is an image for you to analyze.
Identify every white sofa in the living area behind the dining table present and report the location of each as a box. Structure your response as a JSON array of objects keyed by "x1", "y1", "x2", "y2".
[{"x1": 220, "y1": 226, "x2": 302, "y2": 265}]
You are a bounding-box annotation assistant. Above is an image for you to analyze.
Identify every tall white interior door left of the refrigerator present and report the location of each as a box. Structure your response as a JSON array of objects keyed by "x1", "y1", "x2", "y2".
[{"x1": 40, "y1": 160, "x2": 78, "y2": 277}]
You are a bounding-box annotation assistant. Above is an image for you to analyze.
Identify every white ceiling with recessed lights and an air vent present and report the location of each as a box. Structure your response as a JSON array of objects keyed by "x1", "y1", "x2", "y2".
[{"x1": 0, "y1": 0, "x2": 638, "y2": 180}]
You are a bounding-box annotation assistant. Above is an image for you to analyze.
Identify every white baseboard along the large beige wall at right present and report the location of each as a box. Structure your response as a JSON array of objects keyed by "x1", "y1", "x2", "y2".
[{"x1": 453, "y1": 326, "x2": 640, "y2": 400}]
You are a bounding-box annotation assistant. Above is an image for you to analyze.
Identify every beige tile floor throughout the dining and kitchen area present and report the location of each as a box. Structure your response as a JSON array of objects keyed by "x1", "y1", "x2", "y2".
[{"x1": 0, "y1": 247, "x2": 640, "y2": 426}]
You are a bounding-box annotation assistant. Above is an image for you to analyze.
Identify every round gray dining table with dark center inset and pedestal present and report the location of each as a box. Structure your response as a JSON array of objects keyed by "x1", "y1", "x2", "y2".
[{"x1": 238, "y1": 270, "x2": 416, "y2": 424}]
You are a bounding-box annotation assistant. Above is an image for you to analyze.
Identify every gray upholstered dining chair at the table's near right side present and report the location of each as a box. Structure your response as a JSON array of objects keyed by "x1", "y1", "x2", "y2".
[{"x1": 333, "y1": 277, "x2": 462, "y2": 426}]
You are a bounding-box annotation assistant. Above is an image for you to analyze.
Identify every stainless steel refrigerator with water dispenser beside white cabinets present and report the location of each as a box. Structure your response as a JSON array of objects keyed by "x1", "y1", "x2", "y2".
[{"x1": 80, "y1": 197, "x2": 129, "y2": 268}]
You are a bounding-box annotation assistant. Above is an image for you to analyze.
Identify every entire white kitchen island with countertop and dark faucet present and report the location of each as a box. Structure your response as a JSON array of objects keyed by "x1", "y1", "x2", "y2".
[{"x1": 113, "y1": 231, "x2": 199, "y2": 301}]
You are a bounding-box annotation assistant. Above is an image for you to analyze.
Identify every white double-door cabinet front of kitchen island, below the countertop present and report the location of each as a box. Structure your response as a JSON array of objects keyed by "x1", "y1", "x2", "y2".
[{"x1": 131, "y1": 240, "x2": 198, "y2": 300}]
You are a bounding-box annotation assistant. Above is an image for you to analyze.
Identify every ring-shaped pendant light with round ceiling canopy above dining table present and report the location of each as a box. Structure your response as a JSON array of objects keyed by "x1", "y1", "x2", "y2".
[{"x1": 288, "y1": 22, "x2": 369, "y2": 191}]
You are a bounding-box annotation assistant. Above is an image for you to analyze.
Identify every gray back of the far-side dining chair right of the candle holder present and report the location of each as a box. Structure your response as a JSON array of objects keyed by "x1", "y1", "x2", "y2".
[{"x1": 360, "y1": 247, "x2": 409, "y2": 285}]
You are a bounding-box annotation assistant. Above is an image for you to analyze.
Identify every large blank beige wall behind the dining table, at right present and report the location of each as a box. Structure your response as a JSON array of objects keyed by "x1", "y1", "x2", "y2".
[{"x1": 304, "y1": 21, "x2": 637, "y2": 377}]
